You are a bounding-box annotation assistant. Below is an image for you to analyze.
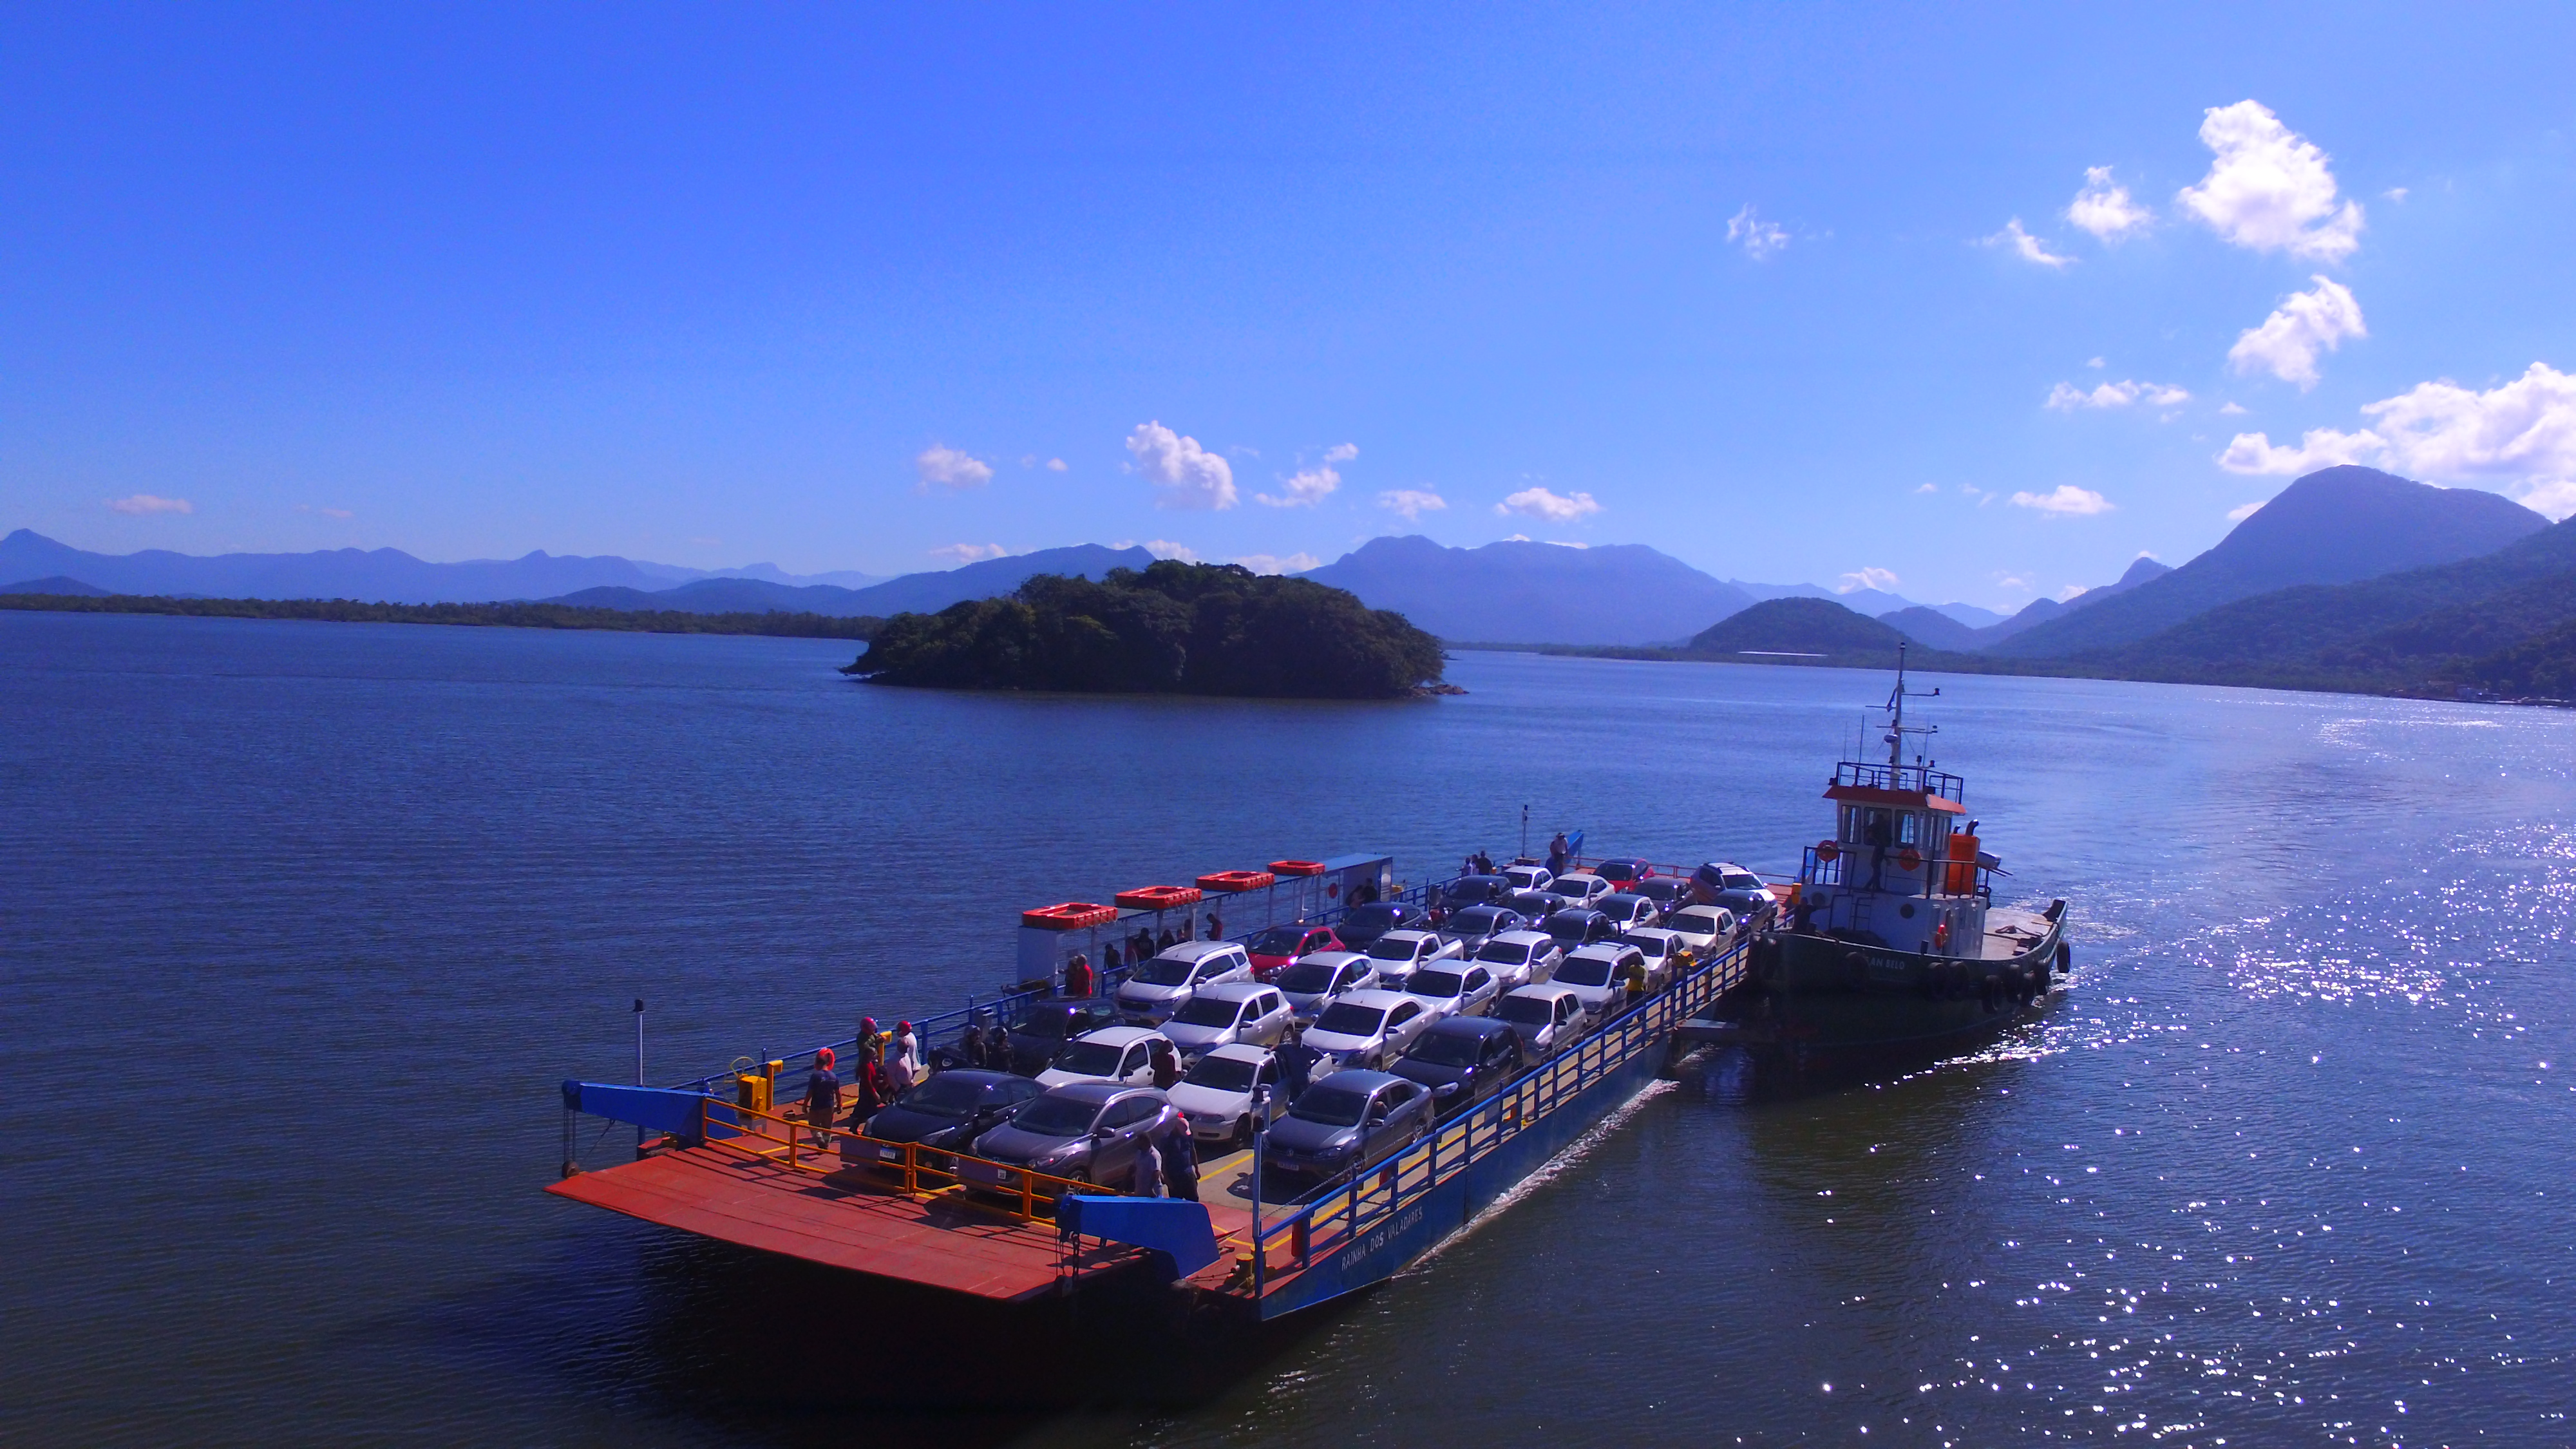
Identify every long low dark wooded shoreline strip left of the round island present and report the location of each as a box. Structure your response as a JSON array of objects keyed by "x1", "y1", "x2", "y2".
[{"x1": 0, "y1": 593, "x2": 884, "y2": 639}]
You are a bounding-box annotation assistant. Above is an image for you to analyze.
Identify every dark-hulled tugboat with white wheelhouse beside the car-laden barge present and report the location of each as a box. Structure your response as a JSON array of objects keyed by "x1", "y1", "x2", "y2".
[{"x1": 1682, "y1": 647, "x2": 2071, "y2": 1067}]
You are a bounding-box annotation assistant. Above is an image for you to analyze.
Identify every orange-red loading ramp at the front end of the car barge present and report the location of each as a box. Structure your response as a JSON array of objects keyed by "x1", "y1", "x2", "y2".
[{"x1": 546, "y1": 1148, "x2": 1249, "y2": 1302}]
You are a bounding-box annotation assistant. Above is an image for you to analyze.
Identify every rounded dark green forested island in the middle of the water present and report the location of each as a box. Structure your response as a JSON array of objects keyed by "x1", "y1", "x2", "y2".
[{"x1": 842, "y1": 560, "x2": 1448, "y2": 699}]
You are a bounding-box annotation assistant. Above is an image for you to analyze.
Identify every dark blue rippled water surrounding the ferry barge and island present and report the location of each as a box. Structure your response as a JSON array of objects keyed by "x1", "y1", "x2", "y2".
[{"x1": 0, "y1": 614, "x2": 2576, "y2": 1446}]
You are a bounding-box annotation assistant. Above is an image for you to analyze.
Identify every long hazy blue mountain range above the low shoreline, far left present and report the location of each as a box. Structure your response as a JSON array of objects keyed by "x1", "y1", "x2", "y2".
[{"x1": 0, "y1": 529, "x2": 871, "y2": 603}]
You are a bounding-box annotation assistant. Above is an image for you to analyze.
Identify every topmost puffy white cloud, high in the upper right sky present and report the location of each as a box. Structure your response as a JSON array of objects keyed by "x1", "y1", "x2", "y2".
[{"x1": 2177, "y1": 100, "x2": 2362, "y2": 263}]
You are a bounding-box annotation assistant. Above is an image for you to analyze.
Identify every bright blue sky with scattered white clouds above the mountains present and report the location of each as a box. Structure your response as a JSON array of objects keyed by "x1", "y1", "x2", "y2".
[{"x1": 0, "y1": 5, "x2": 2576, "y2": 606}]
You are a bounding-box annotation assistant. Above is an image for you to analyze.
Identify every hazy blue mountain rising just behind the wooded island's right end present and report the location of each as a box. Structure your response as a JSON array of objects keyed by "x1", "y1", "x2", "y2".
[{"x1": 1298, "y1": 536, "x2": 1752, "y2": 645}]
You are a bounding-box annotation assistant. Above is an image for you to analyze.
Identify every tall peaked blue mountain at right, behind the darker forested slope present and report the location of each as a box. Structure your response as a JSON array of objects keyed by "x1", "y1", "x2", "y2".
[{"x1": 1991, "y1": 467, "x2": 2550, "y2": 658}]
